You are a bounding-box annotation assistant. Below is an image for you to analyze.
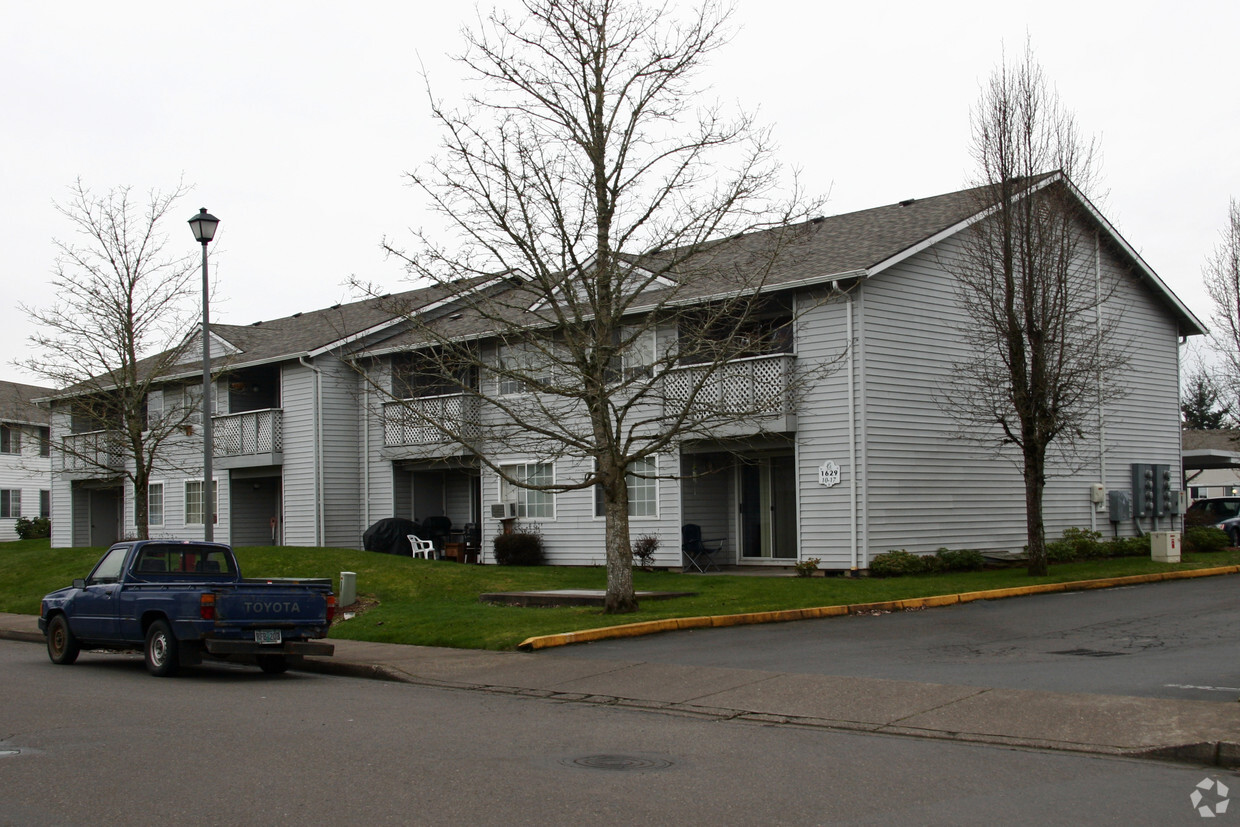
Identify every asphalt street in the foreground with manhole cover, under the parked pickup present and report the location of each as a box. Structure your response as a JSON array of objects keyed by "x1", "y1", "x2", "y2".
[{"x1": 0, "y1": 641, "x2": 1225, "y2": 826}]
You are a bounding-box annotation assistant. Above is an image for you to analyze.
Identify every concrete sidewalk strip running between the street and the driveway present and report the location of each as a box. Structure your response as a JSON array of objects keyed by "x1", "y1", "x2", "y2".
[{"x1": 7, "y1": 614, "x2": 1240, "y2": 767}]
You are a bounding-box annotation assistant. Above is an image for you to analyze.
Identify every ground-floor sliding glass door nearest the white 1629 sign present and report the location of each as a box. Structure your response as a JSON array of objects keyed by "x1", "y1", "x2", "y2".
[{"x1": 737, "y1": 456, "x2": 796, "y2": 560}]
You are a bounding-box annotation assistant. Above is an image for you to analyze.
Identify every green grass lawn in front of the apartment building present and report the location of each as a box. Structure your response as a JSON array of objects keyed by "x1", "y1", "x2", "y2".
[{"x1": 0, "y1": 539, "x2": 1240, "y2": 650}]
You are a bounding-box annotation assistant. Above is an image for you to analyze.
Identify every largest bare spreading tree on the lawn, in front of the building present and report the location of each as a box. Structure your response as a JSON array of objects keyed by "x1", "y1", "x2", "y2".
[{"x1": 376, "y1": 0, "x2": 813, "y2": 613}]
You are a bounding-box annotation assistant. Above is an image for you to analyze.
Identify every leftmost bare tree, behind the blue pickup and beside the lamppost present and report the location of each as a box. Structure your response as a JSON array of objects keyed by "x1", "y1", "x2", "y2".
[{"x1": 22, "y1": 180, "x2": 200, "y2": 538}]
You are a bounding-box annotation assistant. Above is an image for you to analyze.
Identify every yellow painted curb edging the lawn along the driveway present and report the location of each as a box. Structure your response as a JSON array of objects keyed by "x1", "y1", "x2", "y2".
[{"x1": 517, "y1": 565, "x2": 1240, "y2": 652}]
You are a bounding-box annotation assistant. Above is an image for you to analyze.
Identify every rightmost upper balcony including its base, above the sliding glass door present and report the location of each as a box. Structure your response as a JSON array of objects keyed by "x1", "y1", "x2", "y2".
[{"x1": 663, "y1": 353, "x2": 796, "y2": 436}]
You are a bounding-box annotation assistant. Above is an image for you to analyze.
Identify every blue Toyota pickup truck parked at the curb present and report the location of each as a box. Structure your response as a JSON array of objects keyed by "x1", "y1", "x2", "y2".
[{"x1": 38, "y1": 541, "x2": 336, "y2": 677}]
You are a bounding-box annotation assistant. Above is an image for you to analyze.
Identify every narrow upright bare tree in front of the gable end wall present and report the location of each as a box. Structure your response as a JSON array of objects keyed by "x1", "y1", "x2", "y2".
[{"x1": 947, "y1": 45, "x2": 1123, "y2": 575}]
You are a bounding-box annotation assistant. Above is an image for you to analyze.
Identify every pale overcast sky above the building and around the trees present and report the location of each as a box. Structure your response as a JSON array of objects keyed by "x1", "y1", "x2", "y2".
[{"x1": 0, "y1": 0, "x2": 1240, "y2": 382}]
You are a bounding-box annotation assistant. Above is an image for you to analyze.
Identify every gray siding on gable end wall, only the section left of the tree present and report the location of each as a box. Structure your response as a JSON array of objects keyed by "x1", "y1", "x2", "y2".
[{"x1": 863, "y1": 239, "x2": 1024, "y2": 558}]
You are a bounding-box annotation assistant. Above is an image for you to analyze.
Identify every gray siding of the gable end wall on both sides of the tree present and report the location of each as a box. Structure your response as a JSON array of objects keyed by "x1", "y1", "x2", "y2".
[{"x1": 853, "y1": 228, "x2": 1179, "y2": 555}]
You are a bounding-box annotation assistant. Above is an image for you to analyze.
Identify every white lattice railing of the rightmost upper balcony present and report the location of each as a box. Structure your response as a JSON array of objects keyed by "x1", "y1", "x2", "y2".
[{"x1": 663, "y1": 353, "x2": 794, "y2": 417}]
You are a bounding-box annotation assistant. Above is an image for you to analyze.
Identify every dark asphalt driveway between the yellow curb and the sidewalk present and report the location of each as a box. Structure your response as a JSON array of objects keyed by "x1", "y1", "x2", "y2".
[{"x1": 546, "y1": 577, "x2": 1240, "y2": 701}]
